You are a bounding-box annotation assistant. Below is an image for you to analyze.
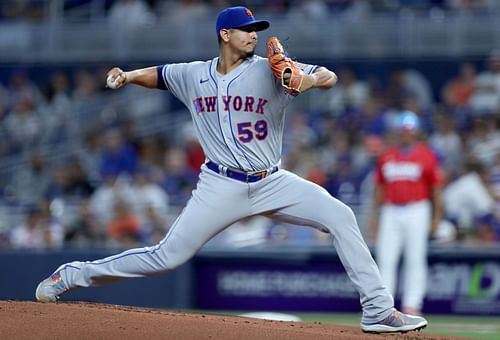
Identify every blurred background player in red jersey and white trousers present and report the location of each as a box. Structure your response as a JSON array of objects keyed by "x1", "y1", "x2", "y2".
[{"x1": 371, "y1": 111, "x2": 443, "y2": 315}]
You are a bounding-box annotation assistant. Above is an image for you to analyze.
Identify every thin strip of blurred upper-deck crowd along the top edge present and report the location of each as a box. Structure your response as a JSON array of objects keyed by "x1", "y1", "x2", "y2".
[{"x1": 0, "y1": 0, "x2": 500, "y2": 24}]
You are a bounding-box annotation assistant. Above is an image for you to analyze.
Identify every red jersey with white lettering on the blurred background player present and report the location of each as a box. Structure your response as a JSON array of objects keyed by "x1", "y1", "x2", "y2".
[{"x1": 375, "y1": 144, "x2": 443, "y2": 204}]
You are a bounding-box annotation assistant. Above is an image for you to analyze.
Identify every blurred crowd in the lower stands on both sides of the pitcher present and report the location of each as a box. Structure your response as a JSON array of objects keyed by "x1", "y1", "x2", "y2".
[{"x1": 0, "y1": 53, "x2": 500, "y2": 249}]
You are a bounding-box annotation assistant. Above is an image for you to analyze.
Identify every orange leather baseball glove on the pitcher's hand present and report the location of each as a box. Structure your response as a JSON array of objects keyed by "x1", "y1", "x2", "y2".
[{"x1": 267, "y1": 37, "x2": 304, "y2": 96}]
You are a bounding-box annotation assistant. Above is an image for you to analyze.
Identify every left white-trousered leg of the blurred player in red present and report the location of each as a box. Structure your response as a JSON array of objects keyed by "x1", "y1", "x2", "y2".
[{"x1": 377, "y1": 206, "x2": 404, "y2": 296}]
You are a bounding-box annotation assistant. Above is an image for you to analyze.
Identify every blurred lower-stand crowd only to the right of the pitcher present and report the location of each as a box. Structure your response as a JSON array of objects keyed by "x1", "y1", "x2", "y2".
[{"x1": 285, "y1": 52, "x2": 500, "y2": 245}]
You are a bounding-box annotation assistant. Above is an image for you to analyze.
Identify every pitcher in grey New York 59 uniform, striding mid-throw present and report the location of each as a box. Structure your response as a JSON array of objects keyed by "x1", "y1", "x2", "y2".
[{"x1": 36, "y1": 7, "x2": 427, "y2": 332}]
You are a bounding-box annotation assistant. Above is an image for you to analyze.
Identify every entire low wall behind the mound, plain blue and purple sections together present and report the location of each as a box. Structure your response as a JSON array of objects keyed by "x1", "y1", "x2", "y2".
[{"x1": 0, "y1": 247, "x2": 500, "y2": 315}]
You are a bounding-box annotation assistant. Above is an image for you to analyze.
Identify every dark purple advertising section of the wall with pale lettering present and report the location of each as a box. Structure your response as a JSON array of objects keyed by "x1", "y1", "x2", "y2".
[{"x1": 194, "y1": 248, "x2": 500, "y2": 315}]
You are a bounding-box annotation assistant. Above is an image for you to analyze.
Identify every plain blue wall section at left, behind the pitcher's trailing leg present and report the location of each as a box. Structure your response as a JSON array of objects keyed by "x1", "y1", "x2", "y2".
[{"x1": 0, "y1": 250, "x2": 194, "y2": 308}]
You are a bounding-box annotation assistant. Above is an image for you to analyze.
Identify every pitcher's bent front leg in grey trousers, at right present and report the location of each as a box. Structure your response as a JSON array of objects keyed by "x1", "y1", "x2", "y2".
[{"x1": 251, "y1": 171, "x2": 394, "y2": 322}]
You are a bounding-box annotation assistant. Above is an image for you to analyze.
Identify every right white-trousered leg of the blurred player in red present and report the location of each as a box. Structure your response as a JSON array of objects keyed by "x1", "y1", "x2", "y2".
[{"x1": 402, "y1": 202, "x2": 431, "y2": 311}]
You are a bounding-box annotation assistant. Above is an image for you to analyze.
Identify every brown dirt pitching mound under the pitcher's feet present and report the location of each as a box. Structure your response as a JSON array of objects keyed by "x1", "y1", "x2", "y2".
[{"x1": 0, "y1": 301, "x2": 464, "y2": 340}]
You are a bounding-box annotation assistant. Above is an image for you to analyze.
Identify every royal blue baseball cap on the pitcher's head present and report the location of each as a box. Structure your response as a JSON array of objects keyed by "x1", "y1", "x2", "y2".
[{"x1": 215, "y1": 6, "x2": 270, "y2": 36}]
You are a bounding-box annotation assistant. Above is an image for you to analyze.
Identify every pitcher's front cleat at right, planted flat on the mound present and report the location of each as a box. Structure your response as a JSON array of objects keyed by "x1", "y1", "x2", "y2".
[{"x1": 361, "y1": 309, "x2": 427, "y2": 333}]
